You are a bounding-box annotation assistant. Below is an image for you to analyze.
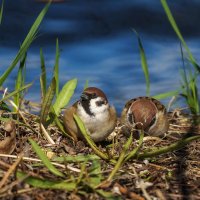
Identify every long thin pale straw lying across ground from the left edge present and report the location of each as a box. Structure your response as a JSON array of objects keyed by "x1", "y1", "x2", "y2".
[{"x1": 0, "y1": 154, "x2": 80, "y2": 173}]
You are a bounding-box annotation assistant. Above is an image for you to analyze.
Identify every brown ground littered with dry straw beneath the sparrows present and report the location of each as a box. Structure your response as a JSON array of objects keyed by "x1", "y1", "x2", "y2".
[{"x1": 0, "y1": 111, "x2": 200, "y2": 200}]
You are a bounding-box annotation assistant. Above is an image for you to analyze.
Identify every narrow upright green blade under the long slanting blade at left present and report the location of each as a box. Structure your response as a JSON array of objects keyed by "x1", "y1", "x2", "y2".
[{"x1": 14, "y1": 54, "x2": 27, "y2": 111}]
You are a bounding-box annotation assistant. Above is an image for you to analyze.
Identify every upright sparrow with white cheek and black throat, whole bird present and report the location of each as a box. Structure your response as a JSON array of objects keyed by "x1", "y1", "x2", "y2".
[{"x1": 63, "y1": 87, "x2": 117, "y2": 142}]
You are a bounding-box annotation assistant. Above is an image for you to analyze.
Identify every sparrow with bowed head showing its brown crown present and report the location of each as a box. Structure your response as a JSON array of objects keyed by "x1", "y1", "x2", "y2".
[{"x1": 121, "y1": 97, "x2": 169, "y2": 136}]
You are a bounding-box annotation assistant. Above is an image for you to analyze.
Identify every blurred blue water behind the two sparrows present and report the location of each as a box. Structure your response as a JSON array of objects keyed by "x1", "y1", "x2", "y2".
[{"x1": 0, "y1": 0, "x2": 200, "y2": 112}]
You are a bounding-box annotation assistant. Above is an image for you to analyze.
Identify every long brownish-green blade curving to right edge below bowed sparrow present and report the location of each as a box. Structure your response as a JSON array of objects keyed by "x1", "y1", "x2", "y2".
[{"x1": 137, "y1": 135, "x2": 200, "y2": 159}]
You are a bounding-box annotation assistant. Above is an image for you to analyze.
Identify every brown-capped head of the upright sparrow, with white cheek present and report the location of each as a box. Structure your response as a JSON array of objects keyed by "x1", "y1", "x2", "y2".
[{"x1": 79, "y1": 87, "x2": 109, "y2": 116}]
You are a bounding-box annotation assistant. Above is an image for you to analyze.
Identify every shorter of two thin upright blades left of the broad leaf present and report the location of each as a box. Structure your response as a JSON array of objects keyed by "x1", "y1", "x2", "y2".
[{"x1": 40, "y1": 49, "x2": 47, "y2": 99}]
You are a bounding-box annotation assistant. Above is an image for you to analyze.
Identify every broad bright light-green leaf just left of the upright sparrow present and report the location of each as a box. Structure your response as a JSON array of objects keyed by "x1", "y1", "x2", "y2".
[{"x1": 53, "y1": 79, "x2": 77, "y2": 116}]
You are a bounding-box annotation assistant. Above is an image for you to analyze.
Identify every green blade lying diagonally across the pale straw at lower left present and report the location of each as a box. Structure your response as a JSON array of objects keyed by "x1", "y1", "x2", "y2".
[{"x1": 29, "y1": 139, "x2": 64, "y2": 177}]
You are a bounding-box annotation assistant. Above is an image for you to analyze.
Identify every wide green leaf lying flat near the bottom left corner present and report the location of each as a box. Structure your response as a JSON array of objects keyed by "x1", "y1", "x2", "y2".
[{"x1": 17, "y1": 171, "x2": 76, "y2": 191}]
